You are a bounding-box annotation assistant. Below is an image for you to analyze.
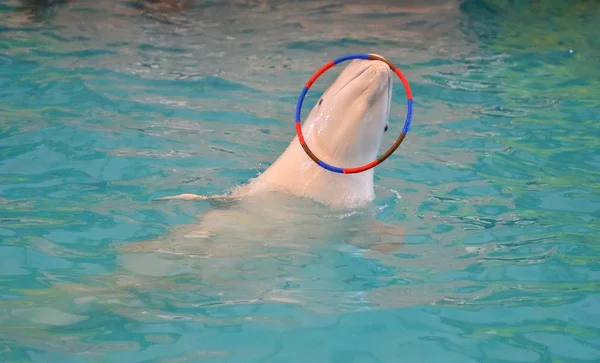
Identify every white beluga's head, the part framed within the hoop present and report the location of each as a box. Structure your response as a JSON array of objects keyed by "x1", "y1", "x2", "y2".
[{"x1": 302, "y1": 55, "x2": 392, "y2": 167}]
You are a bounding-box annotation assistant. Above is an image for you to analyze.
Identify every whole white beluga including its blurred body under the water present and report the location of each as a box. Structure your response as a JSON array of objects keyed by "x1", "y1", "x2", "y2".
[{"x1": 34, "y1": 56, "x2": 404, "y2": 309}]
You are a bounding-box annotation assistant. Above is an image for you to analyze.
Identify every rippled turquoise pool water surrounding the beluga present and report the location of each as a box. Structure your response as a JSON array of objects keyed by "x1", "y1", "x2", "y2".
[{"x1": 0, "y1": 0, "x2": 600, "y2": 363}]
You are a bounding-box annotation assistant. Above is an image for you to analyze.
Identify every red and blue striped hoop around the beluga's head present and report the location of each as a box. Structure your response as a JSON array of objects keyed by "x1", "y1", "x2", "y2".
[{"x1": 296, "y1": 54, "x2": 413, "y2": 174}]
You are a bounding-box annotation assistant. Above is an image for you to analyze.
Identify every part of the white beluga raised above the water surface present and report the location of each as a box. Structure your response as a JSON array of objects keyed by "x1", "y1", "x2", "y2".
[{"x1": 159, "y1": 53, "x2": 393, "y2": 209}]
